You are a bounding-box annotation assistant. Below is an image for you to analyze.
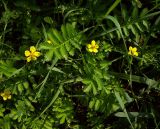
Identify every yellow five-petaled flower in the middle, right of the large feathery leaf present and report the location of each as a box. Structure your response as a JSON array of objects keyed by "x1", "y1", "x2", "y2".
[{"x1": 87, "y1": 40, "x2": 99, "y2": 53}]
